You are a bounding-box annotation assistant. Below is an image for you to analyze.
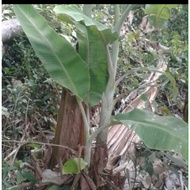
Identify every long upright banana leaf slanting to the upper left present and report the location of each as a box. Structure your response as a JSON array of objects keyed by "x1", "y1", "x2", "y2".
[{"x1": 13, "y1": 4, "x2": 90, "y2": 101}]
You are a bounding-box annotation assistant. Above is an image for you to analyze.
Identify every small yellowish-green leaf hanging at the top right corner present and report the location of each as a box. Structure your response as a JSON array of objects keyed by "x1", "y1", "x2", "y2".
[{"x1": 145, "y1": 4, "x2": 177, "y2": 29}]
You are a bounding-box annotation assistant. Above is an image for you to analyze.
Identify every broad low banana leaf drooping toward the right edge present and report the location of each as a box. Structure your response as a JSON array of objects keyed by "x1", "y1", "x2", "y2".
[{"x1": 113, "y1": 109, "x2": 188, "y2": 161}]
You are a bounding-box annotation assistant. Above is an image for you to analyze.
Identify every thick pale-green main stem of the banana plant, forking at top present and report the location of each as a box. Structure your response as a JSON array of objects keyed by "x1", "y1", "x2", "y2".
[{"x1": 94, "y1": 4, "x2": 136, "y2": 143}]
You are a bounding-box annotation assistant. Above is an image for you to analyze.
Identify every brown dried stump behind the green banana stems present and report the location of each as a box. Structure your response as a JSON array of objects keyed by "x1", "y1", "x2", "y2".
[{"x1": 50, "y1": 88, "x2": 85, "y2": 168}]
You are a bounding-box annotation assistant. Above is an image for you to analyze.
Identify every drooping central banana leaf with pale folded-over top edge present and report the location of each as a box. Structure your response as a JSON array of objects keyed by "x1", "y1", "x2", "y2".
[{"x1": 54, "y1": 5, "x2": 118, "y2": 106}]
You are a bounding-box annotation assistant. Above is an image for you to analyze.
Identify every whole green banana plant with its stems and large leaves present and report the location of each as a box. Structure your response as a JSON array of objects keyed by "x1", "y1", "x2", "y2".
[{"x1": 13, "y1": 4, "x2": 188, "y2": 172}]
